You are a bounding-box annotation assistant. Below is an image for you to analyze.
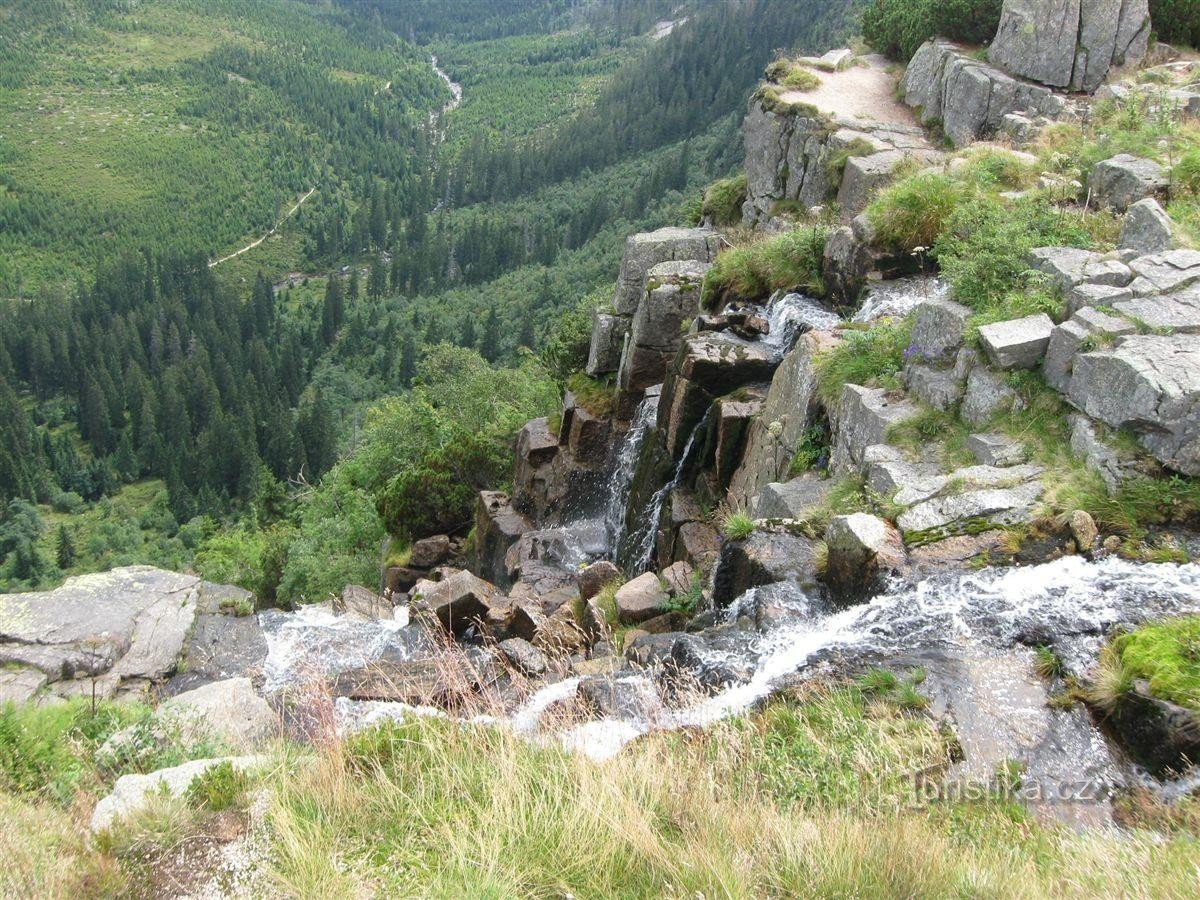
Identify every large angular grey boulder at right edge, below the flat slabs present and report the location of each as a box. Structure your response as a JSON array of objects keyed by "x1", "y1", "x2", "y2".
[{"x1": 1069, "y1": 335, "x2": 1200, "y2": 476}]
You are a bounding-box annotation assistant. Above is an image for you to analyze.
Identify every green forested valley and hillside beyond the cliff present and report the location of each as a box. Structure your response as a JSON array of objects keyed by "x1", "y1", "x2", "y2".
[{"x1": 0, "y1": 0, "x2": 857, "y2": 600}]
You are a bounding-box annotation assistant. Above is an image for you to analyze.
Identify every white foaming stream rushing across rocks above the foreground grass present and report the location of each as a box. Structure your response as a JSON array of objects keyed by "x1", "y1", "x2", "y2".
[{"x1": 514, "y1": 557, "x2": 1200, "y2": 758}]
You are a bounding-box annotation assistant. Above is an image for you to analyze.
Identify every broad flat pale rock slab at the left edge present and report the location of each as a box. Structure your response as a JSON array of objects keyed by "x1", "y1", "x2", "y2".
[{"x1": 0, "y1": 565, "x2": 212, "y2": 697}]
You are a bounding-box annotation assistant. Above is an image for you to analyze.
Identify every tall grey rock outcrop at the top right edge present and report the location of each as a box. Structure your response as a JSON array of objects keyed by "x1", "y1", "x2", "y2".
[{"x1": 988, "y1": 0, "x2": 1150, "y2": 91}]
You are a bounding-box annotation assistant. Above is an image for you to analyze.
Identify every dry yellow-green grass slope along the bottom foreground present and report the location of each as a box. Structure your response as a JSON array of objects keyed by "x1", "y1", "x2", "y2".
[{"x1": 7, "y1": 683, "x2": 1198, "y2": 898}]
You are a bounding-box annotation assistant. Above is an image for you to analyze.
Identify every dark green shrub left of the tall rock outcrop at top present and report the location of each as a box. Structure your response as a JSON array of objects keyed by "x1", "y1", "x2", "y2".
[{"x1": 863, "y1": 0, "x2": 1002, "y2": 62}]
